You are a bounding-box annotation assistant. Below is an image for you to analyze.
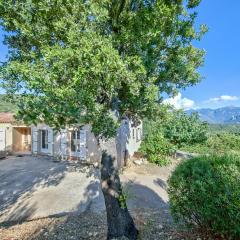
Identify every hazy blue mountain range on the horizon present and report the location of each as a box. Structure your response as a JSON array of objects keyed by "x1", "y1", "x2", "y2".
[{"x1": 187, "y1": 107, "x2": 240, "y2": 124}]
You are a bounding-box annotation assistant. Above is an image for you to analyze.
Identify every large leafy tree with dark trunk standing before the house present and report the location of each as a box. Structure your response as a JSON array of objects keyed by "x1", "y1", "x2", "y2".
[{"x1": 0, "y1": 0, "x2": 206, "y2": 239}]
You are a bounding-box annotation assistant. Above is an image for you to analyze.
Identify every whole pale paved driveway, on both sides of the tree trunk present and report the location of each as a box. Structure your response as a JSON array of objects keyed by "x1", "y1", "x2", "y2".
[{"x1": 0, "y1": 156, "x2": 174, "y2": 223}]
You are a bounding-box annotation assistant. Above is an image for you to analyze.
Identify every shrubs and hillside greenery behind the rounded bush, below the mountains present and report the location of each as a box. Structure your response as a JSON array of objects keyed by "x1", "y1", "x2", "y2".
[{"x1": 140, "y1": 106, "x2": 240, "y2": 165}]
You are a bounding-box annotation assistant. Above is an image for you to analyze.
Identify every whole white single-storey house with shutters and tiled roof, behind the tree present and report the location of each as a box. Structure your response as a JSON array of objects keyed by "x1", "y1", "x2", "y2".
[{"x1": 0, "y1": 113, "x2": 142, "y2": 166}]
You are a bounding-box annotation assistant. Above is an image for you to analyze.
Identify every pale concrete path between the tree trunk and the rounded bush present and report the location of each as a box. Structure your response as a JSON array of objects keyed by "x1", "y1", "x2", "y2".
[{"x1": 121, "y1": 162, "x2": 177, "y2": 222}]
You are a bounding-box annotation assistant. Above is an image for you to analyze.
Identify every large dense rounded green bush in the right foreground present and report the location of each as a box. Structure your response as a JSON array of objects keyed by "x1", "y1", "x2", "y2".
[{"x1": 168, "y1": 155, "x2": 240, "y2": 239}]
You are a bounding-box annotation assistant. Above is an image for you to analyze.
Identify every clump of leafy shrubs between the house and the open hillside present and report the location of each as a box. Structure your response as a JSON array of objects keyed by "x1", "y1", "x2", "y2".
[{"x1": 140, "y1": 108, "x2": 208, "y2": 165}]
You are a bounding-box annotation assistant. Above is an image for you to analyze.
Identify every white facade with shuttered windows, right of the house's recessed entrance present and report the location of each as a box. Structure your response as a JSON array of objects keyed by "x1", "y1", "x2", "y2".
[{"x1": 32, "y1": 120, "x2": 142, "y2": 165}]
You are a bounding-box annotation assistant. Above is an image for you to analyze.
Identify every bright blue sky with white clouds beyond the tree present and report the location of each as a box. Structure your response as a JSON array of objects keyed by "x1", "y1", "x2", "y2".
[{"x1": 0, "y1": 0, "x2": 240, "y2": 108}]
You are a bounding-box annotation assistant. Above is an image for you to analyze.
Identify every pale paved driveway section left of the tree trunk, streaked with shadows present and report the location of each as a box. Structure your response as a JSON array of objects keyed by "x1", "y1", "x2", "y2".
[{"x1": 0, "y1": 156, "x2": 104, "y2": 222}]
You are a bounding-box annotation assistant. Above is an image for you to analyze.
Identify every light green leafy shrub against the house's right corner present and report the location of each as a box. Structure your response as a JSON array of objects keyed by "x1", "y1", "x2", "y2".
[{"x1": 140, "y1": 129, "x2": 174, "y2": 166}]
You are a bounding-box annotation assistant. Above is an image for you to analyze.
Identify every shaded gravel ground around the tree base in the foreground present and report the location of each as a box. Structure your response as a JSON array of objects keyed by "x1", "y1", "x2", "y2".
[{"x1": 0, "y1": 209, "x2": 204, "y2": 240}]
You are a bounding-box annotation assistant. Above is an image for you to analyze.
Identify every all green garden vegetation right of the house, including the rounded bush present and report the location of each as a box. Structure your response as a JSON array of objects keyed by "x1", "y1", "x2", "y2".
[{"x1": 141, "y1": 108, "x2": 240, "y2": 239}]
